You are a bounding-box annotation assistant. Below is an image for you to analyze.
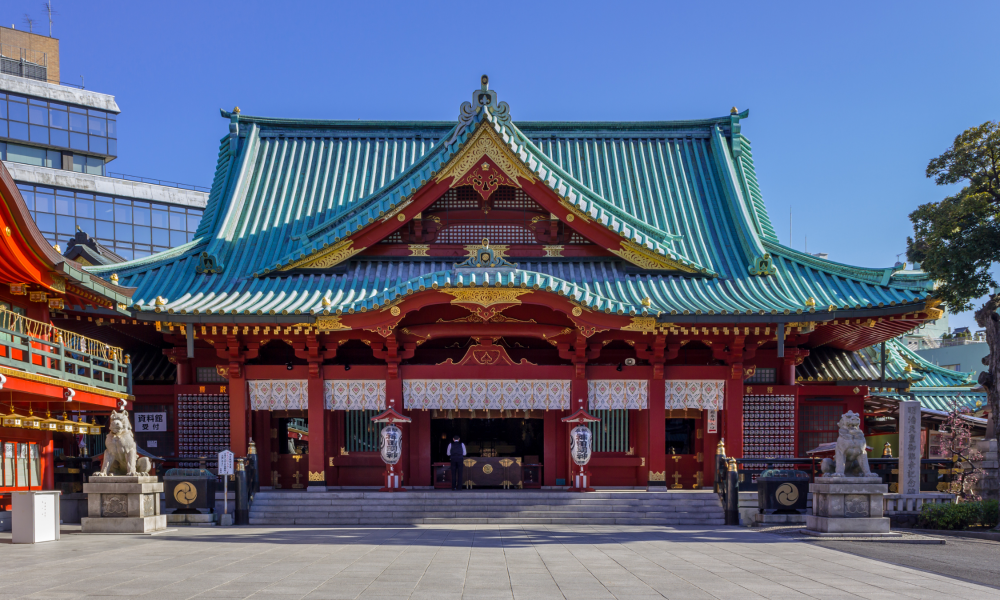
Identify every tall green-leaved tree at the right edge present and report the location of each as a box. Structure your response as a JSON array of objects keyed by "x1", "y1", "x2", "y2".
[{"x1": 907, "y1": 121, "x2": 1000, "y2": 510}]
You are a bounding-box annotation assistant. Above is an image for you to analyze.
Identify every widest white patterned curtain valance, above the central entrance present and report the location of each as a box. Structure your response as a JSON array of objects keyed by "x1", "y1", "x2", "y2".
[{"x1": 403, "y1": 379, "x2": 570, "y2": 410}]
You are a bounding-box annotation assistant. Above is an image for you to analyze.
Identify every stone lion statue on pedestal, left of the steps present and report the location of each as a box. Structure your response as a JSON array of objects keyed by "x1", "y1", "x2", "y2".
[{"x1": 80, "y1": 405, "x2": 167, "y2": 533}]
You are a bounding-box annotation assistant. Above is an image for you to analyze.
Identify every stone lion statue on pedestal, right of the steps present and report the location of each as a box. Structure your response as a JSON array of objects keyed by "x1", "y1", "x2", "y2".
[{"x1": 802, "y1": 411, "x2": 901, "y2": 537}]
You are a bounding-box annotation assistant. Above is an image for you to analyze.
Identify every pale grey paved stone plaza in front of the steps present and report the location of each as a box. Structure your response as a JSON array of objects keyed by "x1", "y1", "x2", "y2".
[{"x1": 0, "y1": 525, "x2": 998, "y2": 600}]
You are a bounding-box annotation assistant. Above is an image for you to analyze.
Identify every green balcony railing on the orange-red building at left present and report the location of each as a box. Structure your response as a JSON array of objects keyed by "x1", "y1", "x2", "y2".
[{"x1": 0, "y1": 308, "x2": 129, "y2": 393}]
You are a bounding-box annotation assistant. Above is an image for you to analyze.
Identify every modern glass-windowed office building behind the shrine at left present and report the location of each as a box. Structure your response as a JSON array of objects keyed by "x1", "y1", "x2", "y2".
[{"x1": 0, "y1": 27, "x2": 208, "y2": 259}]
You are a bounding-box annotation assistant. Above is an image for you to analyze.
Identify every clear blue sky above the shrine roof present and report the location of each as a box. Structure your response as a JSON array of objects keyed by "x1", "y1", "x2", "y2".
[{"x1": 7, "y1": 0, "x2": 1000, "y2": 326}]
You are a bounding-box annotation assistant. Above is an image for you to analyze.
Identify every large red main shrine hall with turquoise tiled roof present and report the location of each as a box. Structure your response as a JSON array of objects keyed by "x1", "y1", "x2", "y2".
[{"x1": 88, "y1": 77, "x2": 938, "y2": 489}]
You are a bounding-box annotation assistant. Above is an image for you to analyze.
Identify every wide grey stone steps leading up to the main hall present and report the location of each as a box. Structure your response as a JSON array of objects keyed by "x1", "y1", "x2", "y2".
[{"x1": 250, "y1": 490, "x2": 725, "y2": 526}]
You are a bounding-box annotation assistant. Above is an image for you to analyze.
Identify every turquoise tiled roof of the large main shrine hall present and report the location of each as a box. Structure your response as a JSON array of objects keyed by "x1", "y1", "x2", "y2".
[{"x1": 92, "y1": 85, "x2": 931, "y2": 316}]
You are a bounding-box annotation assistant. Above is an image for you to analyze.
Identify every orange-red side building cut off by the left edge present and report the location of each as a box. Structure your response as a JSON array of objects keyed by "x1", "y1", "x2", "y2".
[{"x1": 0, "y1": 163, "x2": 131, "y2": 502}]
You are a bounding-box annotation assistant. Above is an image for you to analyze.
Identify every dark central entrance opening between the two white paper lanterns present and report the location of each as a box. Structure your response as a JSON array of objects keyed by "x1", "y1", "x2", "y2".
[{"x1": 431, "y1": 410, "x2": 545, "y2": 489}]
